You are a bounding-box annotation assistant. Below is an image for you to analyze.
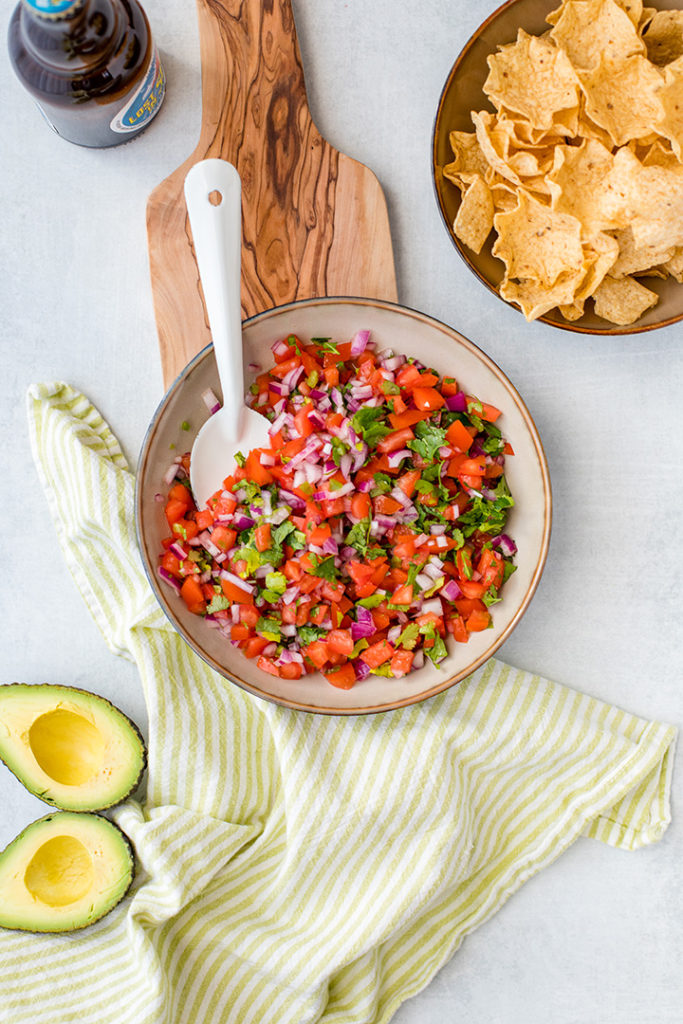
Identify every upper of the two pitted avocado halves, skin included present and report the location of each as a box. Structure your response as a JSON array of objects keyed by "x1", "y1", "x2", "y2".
[{"x1": 0, "y1": 683, "x2": 146, "y2": 811}]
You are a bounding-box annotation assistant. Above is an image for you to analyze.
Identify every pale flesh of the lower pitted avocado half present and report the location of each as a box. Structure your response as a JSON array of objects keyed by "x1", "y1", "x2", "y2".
[{"x1": 0, "y1": 811, "x2": 133, "y2": 932}]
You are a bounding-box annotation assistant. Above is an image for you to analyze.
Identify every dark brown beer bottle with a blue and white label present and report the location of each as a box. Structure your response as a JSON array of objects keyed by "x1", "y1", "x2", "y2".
[{"x1": 8, "y1": 0, "x2": 166, "y2": 146}]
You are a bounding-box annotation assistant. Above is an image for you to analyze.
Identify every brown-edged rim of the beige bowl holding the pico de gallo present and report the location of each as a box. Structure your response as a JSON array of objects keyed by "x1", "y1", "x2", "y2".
[{"x1": 134, "y1": 295, "x2": 553, "y2": 717}]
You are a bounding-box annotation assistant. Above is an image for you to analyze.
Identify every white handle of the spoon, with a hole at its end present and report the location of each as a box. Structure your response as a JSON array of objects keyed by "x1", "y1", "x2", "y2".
[{"x1": 185, "y1": 160, "x2": 245, "y2": 440}]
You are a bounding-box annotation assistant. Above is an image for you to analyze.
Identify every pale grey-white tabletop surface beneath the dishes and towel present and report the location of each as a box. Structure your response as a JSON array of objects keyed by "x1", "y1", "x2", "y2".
[{"x1": 0, "y1": 0, "x2": 683, "y2": 1024}]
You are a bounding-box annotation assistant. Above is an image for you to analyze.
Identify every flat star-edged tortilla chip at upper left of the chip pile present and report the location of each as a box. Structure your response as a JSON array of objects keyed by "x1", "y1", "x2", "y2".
[{"x1": 483, "y1": 29, "x2": 579, "y2": 129}]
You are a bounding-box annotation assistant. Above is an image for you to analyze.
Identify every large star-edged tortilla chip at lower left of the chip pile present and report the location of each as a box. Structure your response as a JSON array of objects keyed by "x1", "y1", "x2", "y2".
[{"x1": 493, "y1": 191, "x2": 584, "y2": 289}]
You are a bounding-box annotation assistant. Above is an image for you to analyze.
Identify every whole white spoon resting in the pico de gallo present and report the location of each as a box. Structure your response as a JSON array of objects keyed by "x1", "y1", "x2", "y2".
[{"x1": 185, "y1": 160, "x2": 270, "y2": 508}]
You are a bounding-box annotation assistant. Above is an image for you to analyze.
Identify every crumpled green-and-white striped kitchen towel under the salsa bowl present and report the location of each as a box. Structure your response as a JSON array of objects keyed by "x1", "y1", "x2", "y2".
[{"x1": 0, "y1": 384, "x2": 676, "y2": 1024}]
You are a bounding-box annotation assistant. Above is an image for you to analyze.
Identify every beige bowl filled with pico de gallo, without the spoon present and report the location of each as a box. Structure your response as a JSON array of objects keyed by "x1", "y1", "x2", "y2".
[{"x1": 136, "y1": 298, "x2": 552, "y2": 715}]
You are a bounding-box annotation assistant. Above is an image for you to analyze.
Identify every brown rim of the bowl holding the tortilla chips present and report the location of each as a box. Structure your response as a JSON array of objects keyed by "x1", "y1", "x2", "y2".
[{"x1": 431, "y1": 0, "x2": 683, "y2": 337}]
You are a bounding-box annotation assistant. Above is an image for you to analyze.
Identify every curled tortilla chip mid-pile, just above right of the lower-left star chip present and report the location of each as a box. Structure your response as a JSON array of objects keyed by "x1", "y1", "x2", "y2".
[{"x1": 548, "y1": 139, "x2": 628, "y2": 238}]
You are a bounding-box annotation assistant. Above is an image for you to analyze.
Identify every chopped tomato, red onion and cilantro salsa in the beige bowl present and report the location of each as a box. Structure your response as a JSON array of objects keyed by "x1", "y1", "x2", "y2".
[{"x1": 158, "y1": 331, "x2": 516, "y2": 689}]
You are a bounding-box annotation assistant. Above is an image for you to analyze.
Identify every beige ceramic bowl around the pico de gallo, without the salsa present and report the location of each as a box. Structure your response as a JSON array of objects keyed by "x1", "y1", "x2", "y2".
[{"x1": 136, "y1": 298, "x2": 552, "y2": 715}]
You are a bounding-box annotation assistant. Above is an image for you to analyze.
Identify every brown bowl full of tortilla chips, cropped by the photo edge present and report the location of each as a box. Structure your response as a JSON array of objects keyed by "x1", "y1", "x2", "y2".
[{"x1": 433, "y1": 0, "x2": 683, "y2": 334}]
